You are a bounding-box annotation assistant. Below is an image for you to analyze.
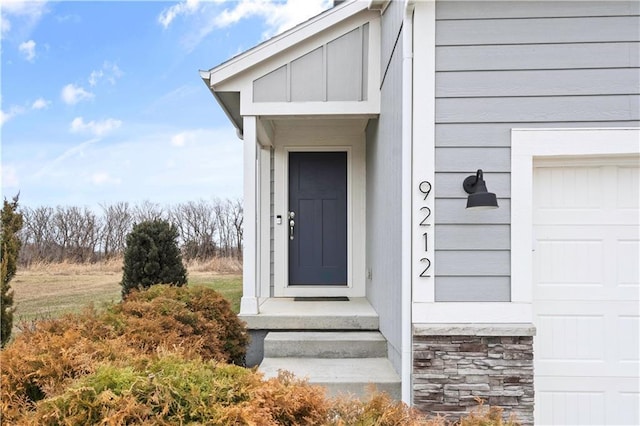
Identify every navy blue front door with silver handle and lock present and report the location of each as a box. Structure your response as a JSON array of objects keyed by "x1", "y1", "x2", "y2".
[{"x1": 287, "y1": 152, "x2": 347, "y2": 285}]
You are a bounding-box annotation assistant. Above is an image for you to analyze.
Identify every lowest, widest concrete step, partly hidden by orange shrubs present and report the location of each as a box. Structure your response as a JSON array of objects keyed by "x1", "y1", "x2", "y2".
[{"x1": 259, "y1": 358, "x2": 401, "y2": 400}]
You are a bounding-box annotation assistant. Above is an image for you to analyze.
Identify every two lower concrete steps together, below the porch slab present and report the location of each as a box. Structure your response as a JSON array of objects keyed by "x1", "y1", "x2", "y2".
[{"x1": 259, "y1": 331, "x2": 401, "y2": 399}]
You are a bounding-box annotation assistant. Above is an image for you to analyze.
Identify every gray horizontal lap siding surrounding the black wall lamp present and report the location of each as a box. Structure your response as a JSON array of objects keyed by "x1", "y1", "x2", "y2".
[{"x1": 432, "y1": 1, "x2": 640, "y2": 301}]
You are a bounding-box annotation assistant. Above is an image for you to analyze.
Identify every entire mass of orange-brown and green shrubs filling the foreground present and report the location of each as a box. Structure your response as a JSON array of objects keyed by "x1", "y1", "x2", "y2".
[{"x1": 0, "y1": 286, "x2": 517, "y2": 426}]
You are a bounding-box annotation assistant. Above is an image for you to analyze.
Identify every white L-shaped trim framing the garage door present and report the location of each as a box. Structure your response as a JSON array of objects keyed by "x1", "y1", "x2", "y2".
[{"x1": 511, "y1": 128, "x2": 640, "y2": 321}]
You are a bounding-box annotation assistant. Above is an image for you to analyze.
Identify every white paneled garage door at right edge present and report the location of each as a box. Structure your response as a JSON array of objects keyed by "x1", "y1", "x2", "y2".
[{"x1": 533, "y1": 156, "x2": 640, "y2": 425}]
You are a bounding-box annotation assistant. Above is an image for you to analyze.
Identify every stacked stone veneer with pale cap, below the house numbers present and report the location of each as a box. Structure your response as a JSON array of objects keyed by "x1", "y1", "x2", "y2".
[{"x1": 412, "y1": 325, "x2": 535, "y2": 425}]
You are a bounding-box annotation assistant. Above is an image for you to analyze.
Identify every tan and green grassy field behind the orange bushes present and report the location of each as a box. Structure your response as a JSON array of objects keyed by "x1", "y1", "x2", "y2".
[{"x1": 11, "y1": 261, "x2": 242, "y2": 325}]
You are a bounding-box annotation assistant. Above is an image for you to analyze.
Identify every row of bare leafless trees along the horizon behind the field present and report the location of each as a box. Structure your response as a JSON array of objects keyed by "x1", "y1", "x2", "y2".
[{"x1": 19, "y1": 198, "x2": 243, "y2": 266}]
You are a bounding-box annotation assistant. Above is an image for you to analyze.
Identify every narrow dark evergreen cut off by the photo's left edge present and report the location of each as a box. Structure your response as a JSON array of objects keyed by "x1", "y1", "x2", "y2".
[{"x1": 0, "y1": 195, "x2": 22, "y2": 346}]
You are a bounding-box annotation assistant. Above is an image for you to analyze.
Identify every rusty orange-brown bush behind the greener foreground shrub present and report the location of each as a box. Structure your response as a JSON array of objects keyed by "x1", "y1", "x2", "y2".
[{"x1": 0, "y1": 286, "x2": 248, "y2": 420}]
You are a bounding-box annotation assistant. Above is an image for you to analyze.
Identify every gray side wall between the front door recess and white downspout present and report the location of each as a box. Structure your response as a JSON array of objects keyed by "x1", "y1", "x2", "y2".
[{"x1": 366, "y1": 2, "x2": 402, "y2": 371}]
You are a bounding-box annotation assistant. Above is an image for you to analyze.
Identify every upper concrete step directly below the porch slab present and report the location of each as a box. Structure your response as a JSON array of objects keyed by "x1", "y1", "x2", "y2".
[{"x1": 264, "y1": 331, "x2": 387, "y2": 358}]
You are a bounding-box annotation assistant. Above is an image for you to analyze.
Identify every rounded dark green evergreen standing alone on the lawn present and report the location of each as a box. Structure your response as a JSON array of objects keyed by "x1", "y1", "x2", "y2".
[{"x1": 121, "y1": 220, "x2": 187, "y2": 298}]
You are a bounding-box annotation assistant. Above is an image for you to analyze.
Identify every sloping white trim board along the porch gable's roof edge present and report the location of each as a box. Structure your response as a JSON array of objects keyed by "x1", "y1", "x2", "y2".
[{"x1": 200, "y1": 1, "x2": 368, "y2": 87}]
